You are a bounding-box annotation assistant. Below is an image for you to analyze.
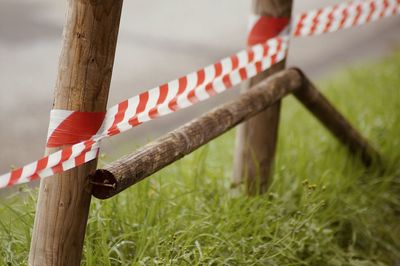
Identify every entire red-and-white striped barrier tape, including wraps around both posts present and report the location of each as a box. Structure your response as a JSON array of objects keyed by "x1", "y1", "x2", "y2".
[{"x1": 0, "y1": 0, "x2": 400, "y2": 188}]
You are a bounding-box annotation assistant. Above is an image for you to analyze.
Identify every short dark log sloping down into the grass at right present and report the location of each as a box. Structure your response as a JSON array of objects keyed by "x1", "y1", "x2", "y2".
[{"x1": 293, "y1": 69, "x2": 379, "y2": 166}]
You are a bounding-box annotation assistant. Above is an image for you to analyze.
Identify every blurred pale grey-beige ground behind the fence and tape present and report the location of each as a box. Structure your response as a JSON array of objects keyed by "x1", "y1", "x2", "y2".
[{"x1": 0, "y1": 0, "x2": 400, "y2": 173}]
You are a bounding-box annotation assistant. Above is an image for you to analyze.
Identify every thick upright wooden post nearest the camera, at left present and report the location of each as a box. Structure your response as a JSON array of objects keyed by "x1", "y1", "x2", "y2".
[{"x1": 29, "y1": 0, "x2": 122, "y2": 266}]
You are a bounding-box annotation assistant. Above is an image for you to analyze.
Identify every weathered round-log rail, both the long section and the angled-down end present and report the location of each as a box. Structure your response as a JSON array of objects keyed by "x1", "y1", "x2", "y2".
[{"x1": 90, "y1": 69, "x2": 378, "y2": 199}]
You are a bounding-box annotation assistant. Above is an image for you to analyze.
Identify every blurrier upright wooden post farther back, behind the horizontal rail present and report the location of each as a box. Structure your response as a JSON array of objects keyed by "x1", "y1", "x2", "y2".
[{"x1": 233, "y1": 0, "x2": 292, "y2": 195}]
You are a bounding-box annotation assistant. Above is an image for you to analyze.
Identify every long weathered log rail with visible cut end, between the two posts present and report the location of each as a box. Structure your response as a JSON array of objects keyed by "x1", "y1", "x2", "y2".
[{"x1": 91, "y1": 70, "x2": 302, "y2": 199}]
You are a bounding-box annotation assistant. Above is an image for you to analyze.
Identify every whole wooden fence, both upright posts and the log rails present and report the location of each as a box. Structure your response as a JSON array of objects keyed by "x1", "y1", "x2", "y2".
[{"x1": 29, "y1": 0, "x2": 379, "y2": 266}]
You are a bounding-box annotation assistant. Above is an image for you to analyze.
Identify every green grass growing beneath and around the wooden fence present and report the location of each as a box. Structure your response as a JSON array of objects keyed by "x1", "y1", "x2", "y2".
[{"x1": 0, "y1": 53, "x2": 400, "y2": 265}]
